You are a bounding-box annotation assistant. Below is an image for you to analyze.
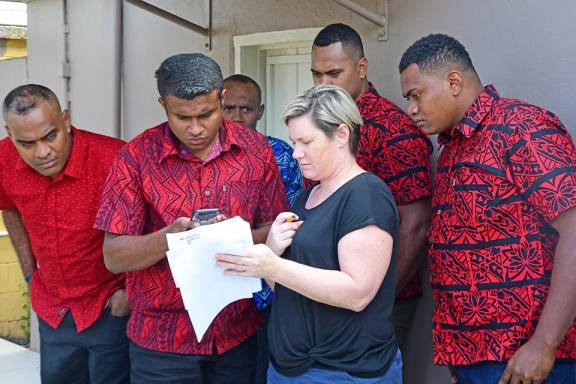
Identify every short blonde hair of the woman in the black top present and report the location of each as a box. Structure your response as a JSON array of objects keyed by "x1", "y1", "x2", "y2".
[{"x1": 282, "y1": 85, "x2": 362, "y2": 155}]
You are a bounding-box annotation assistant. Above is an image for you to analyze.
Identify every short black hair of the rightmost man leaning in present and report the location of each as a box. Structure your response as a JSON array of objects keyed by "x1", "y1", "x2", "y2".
[{"x1": 398, "y1": 33, "x2": 476, "y2": 74}]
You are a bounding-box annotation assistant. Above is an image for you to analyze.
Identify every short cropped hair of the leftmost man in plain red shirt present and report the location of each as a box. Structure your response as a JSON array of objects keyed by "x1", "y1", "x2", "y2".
[{"x1": 2, "y1": 84, "x2": 60, "y2": 121}]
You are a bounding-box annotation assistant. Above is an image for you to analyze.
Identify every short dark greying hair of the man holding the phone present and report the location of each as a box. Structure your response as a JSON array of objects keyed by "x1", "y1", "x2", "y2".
[{"x1": 155, "y1": 53, "x2": 222, "y2": 100}]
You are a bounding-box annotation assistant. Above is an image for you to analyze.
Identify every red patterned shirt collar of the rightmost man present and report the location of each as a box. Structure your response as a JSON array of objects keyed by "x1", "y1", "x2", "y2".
[{"x1": 438, "y1": 84, "x2": 500, "y2": 145}]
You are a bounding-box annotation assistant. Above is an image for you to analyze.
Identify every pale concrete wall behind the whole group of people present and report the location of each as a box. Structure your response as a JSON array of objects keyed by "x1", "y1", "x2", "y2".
[{"x1": 18, "y1": 0, "x2": 576, "y2": 384}]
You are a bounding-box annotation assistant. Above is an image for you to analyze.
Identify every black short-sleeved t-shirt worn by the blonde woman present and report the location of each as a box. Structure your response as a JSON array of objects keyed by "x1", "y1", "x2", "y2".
[{"x1": 268, "y1": 172, "x2": 399, "y2": 377}]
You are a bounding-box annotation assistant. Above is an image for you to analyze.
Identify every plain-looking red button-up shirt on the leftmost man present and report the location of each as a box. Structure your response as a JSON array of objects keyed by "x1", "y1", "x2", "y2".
[{"x1": 0, "y1": 128, "x2": 124, "y2": 332}]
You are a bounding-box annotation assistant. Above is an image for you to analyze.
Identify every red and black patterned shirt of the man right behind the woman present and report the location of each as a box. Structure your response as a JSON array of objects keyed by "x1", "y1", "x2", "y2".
[{"x1": 356, "y1": 83, "x2": 432, "y2": 301}]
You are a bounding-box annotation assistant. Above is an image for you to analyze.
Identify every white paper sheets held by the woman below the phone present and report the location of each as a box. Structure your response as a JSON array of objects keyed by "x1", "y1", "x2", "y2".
[{"x1": 166, "y1": 216, "x2": 262, "y2": 341}]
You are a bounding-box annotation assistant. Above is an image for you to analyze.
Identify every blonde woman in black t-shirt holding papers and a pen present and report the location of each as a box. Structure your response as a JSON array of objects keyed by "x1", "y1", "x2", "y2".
[{"x1": 217, "y1": 85, "x2": 402, "y2": 384}]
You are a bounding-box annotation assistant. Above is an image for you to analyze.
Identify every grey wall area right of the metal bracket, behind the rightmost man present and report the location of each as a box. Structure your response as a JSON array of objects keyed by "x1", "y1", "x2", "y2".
[{"x1": 368, "y1": 0, "x2": 576, "y2": 136}]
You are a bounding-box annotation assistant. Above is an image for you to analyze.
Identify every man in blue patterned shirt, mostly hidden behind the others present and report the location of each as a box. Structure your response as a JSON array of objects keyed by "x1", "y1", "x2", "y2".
[{"x1": 222, "y1": 74, "x2": 304, "y2": 384}]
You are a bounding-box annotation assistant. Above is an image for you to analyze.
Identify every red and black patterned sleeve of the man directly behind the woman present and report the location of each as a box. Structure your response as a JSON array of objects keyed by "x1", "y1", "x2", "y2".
[{"x1": 361, "y1": 106, "x2": 433, "y2": 205}]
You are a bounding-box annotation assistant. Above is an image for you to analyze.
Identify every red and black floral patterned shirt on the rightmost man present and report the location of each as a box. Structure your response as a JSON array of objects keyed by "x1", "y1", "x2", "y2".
[{"x1": 428, "y1": 86, "x2": 576, "y2": 365}]
